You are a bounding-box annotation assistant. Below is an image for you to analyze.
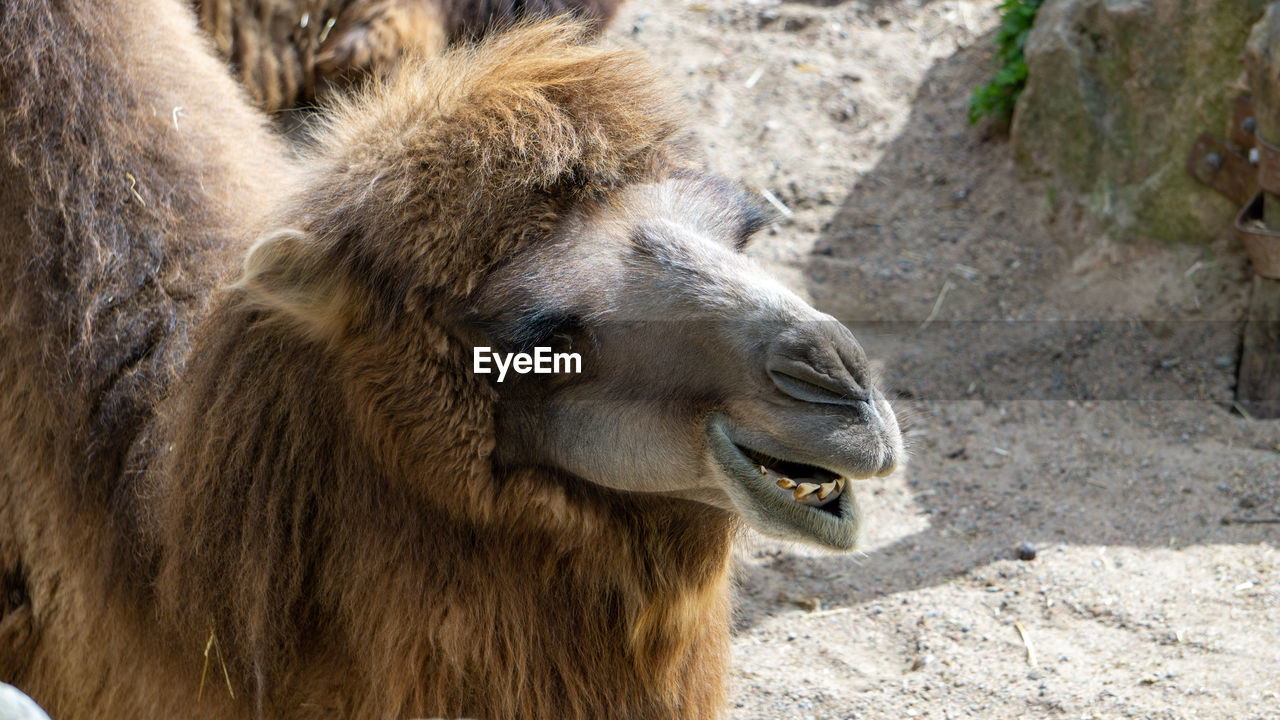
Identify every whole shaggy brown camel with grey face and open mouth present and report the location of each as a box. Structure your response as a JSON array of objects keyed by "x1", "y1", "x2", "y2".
[{"x1": 0, "y1": 0, "x2": 902, "y2": 720}]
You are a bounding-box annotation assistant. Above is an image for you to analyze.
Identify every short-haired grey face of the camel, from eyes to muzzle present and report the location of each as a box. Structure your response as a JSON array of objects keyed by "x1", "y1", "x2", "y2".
[{"x1": 475, "y1": 177, "x2": 904, "y2": 550}]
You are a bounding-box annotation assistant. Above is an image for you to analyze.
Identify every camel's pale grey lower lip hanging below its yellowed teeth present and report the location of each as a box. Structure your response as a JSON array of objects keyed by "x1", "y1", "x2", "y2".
[{"x1": 707, "y1": 413, "x2": 861, "y2": 550}]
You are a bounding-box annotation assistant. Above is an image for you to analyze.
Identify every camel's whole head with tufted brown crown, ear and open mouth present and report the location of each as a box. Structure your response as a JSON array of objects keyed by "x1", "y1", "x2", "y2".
[{"x1": 239, "y1": 23, "x2": 902, "y2": 548}]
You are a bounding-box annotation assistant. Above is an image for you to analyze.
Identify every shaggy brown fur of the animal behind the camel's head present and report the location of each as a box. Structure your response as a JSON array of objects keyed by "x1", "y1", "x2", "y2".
[{"x1": 195, "y1": 0, "x2": 620, "y2": 111}]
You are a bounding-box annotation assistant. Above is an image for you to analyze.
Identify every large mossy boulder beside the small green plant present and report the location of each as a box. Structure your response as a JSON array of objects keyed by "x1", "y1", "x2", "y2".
[{"x1": 1011, "y1": 0, "x2": 1266, "y2": 242}]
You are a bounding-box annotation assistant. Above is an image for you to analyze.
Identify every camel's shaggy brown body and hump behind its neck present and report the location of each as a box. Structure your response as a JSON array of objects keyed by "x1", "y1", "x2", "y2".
[{"x1": 0, "y1": 0, "x2": 289, "y2": 717}]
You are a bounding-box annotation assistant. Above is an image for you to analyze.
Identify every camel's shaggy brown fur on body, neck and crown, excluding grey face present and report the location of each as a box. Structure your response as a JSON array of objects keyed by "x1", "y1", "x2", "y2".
[{"x1": 0, "y1": 0, "x2": 733, "y2": 720}]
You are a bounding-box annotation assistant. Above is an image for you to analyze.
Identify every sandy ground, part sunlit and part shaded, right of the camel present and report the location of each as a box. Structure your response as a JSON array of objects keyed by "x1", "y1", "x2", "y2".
[{"x1": 611, "y1": 0, "x2": 1280, "y2": 719}]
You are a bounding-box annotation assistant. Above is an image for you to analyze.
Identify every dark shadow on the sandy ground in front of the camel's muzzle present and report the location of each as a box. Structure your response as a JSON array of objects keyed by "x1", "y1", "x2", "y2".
[{"x1": 739, "y1": 33, "x2": 1280, "y2": 629}]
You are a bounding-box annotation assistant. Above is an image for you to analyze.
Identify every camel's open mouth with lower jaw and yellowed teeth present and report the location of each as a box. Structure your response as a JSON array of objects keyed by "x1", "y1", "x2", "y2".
[{"x1": 705, "y1": 413, "x2": 886, "y2": 551}]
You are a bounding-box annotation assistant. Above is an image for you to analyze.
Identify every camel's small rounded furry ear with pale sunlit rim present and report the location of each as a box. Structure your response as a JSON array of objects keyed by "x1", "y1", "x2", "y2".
[{"x1": 233, "y1": 229, "x2": 355, "y2": 341}]
